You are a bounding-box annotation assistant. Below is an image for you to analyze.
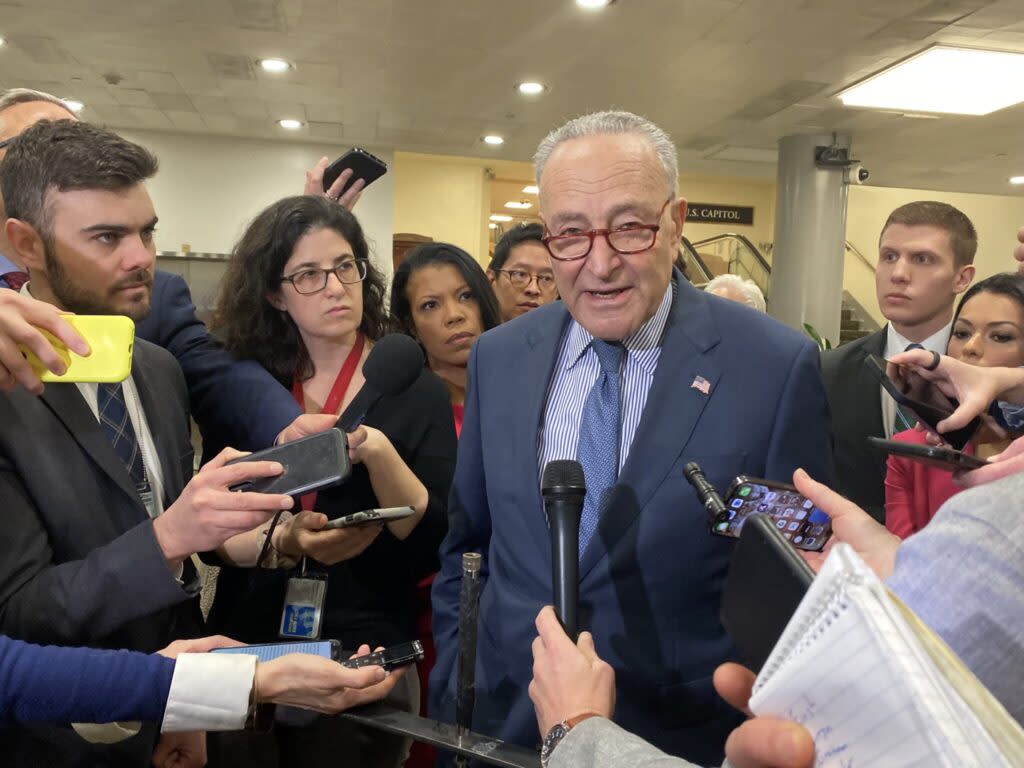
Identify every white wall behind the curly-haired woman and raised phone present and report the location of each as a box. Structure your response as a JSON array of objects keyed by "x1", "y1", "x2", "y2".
[{"x1": 124, "y1": 131, "x2": 394, "y2": 275}]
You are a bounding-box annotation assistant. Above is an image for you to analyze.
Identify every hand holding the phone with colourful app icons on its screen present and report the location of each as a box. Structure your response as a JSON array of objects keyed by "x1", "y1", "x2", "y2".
[{"x1": 793, "y1": 469, "x2": 900, "y2": 579}]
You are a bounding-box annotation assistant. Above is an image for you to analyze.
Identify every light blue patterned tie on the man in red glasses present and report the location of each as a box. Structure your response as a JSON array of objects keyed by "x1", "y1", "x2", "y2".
[{"x1": 577, "y1": 339, "x2": 626, "y2": 560}]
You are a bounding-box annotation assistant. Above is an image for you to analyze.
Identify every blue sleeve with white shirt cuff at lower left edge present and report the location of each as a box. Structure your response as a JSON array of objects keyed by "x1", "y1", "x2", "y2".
[{"x1": 0, "y1": 636, "x2": 174, "y2": 725}]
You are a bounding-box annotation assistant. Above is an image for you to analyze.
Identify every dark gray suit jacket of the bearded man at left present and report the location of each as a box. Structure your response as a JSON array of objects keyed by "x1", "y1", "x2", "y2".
[{"x1": 0, "y1": 341, "x2": 202, "y2": 766}]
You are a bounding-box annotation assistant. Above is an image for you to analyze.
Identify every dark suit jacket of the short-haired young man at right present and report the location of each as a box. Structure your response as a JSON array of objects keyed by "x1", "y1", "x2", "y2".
[{"x1": 821, "y1": 327, "x2": 887, "y2": 522}]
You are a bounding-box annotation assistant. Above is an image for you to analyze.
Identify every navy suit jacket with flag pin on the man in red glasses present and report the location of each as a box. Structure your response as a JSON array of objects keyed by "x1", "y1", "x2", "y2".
[{"x1": 431, "y1": 273, "x2": 831, "y2": 765}]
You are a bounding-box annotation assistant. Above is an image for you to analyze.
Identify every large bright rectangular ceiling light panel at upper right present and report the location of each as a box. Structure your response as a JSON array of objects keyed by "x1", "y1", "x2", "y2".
[{"x1": 839, "y1": 45, "x2": 1024, "y2": 115}]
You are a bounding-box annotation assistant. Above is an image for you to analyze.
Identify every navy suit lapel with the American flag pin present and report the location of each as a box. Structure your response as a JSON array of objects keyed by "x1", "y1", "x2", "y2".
[{"x1": 580, "y1": 286, "x2": 721, "y2": 579}]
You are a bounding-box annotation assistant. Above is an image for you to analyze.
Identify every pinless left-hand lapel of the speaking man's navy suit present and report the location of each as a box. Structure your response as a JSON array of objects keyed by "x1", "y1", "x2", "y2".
[{"x1": 516, "y1": 301, "x2": 569, "y2": 553}]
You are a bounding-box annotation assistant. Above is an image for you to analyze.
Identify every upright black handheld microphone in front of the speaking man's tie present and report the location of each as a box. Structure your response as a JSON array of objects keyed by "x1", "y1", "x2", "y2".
[{"x1": 541, "y1": 460, "x2": 587, "y2": 642}]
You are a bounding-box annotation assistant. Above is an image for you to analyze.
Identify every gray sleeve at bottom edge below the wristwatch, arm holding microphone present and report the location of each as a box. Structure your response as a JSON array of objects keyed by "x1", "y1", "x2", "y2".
[{"x1": 548, "y1": 718, "x2": 695, "y2": 768}]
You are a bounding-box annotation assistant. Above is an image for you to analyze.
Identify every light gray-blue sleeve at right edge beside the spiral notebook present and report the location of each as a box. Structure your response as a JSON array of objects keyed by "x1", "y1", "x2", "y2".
[{"x1": 888, "y1": 473, "x2": 1024, "y2": 722}]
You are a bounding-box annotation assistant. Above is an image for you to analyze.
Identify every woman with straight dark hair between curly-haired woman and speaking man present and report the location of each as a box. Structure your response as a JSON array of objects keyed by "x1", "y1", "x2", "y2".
[{"x1": 391, "y1": 243, "x2": 501, "y2": 768}]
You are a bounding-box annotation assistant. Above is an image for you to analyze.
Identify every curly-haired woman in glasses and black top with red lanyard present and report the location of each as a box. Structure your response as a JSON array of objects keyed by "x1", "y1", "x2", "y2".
[{"x1": 209, "y1": 197, "x2": 456, "y2": 768}]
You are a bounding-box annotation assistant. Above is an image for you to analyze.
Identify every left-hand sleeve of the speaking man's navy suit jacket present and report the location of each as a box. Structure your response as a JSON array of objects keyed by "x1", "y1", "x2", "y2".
[{"x1": 429, "y1": 346, "x2": 490, "y2": 722}]
